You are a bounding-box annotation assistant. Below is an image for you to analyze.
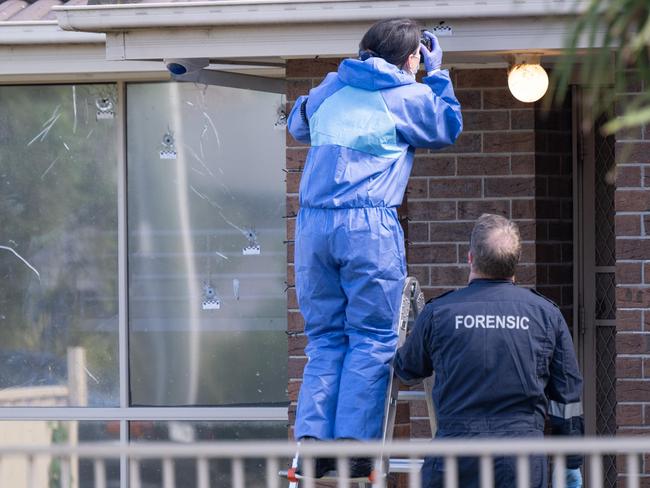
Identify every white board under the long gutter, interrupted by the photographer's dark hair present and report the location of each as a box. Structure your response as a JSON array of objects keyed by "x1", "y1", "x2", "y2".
[{"x1": 106, "y1": 17, "x2": 587, "y2": 61}]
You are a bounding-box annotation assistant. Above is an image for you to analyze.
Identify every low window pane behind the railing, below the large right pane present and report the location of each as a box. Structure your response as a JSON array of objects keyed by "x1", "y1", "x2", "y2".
[{"x1": 129, "y1": 421, "x2": 289, "y2": 488}]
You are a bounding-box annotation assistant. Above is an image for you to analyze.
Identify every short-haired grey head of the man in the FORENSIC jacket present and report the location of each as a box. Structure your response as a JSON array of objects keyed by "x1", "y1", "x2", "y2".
[{"x1": 469, "y1": 214, "x2": 521, "y2": 278}]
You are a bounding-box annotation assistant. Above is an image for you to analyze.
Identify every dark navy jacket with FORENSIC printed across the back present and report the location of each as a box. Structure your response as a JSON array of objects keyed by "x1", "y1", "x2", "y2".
[{"x1": 395, "y1": 279, "x2": 583, "y2": 486}]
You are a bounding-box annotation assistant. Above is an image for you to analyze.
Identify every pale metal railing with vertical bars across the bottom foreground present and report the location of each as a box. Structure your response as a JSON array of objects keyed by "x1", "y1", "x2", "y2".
[{"x1": 0, "y1": 437, "x2": 650, "y2": 488}]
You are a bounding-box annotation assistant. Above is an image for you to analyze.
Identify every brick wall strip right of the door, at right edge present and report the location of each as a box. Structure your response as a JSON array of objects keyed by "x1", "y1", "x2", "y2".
[{"x1": 615, "y1": 73, "x2": 650, "y2": 487}]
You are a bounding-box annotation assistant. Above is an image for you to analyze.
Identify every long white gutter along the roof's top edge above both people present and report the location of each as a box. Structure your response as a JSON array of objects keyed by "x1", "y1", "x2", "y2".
[{"x1": 53, "y1": 0, "x2": 587, "y2": 32}]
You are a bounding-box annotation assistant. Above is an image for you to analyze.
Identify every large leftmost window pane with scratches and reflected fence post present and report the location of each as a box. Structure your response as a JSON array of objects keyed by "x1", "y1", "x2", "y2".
[{"x1": 0, "y1": 84, "x2": 119, "y2": 407}]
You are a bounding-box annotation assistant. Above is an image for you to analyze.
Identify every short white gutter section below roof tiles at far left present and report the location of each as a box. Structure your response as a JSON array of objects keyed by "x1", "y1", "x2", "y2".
[{"x1": 0, "y1": 20, "x2": 106, "y2": 46}]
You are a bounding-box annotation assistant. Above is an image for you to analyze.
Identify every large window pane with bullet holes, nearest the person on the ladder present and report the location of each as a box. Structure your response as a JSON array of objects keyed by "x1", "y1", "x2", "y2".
[{"x1": 127, "y1": 83, "x2": 287, "y2": 406}]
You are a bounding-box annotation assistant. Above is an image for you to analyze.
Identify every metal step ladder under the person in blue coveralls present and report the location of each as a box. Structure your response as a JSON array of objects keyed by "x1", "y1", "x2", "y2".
[{"x1": 279, "y1": 277, "x2": 437, "y2": 488}]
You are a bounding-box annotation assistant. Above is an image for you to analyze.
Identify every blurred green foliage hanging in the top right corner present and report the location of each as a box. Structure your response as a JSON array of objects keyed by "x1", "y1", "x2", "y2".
[{"x1": 552, "y1": 0, "x2": 650, "y2": 134}]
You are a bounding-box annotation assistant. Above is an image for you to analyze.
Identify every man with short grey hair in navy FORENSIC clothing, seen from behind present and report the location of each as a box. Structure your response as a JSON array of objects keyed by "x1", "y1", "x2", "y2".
[{"x1": 395, "y1": 214, "x2": 583, "y2": 488}]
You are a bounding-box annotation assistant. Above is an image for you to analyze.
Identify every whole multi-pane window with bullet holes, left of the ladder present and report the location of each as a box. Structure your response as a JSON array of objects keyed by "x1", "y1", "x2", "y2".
[{"x1": 0, "y1": 78, "x2": 288, "y2": 486}]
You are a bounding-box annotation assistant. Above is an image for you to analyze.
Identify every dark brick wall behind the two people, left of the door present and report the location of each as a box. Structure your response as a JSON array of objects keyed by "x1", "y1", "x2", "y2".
[{"x1": 287, "y1": 63, "x2": 572, "y2": 448}]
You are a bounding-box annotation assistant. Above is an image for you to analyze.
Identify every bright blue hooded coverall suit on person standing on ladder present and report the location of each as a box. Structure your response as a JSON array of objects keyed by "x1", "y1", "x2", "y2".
[{"x1": 288, "y1": 57, "x2": 462, "y2": 440}]
